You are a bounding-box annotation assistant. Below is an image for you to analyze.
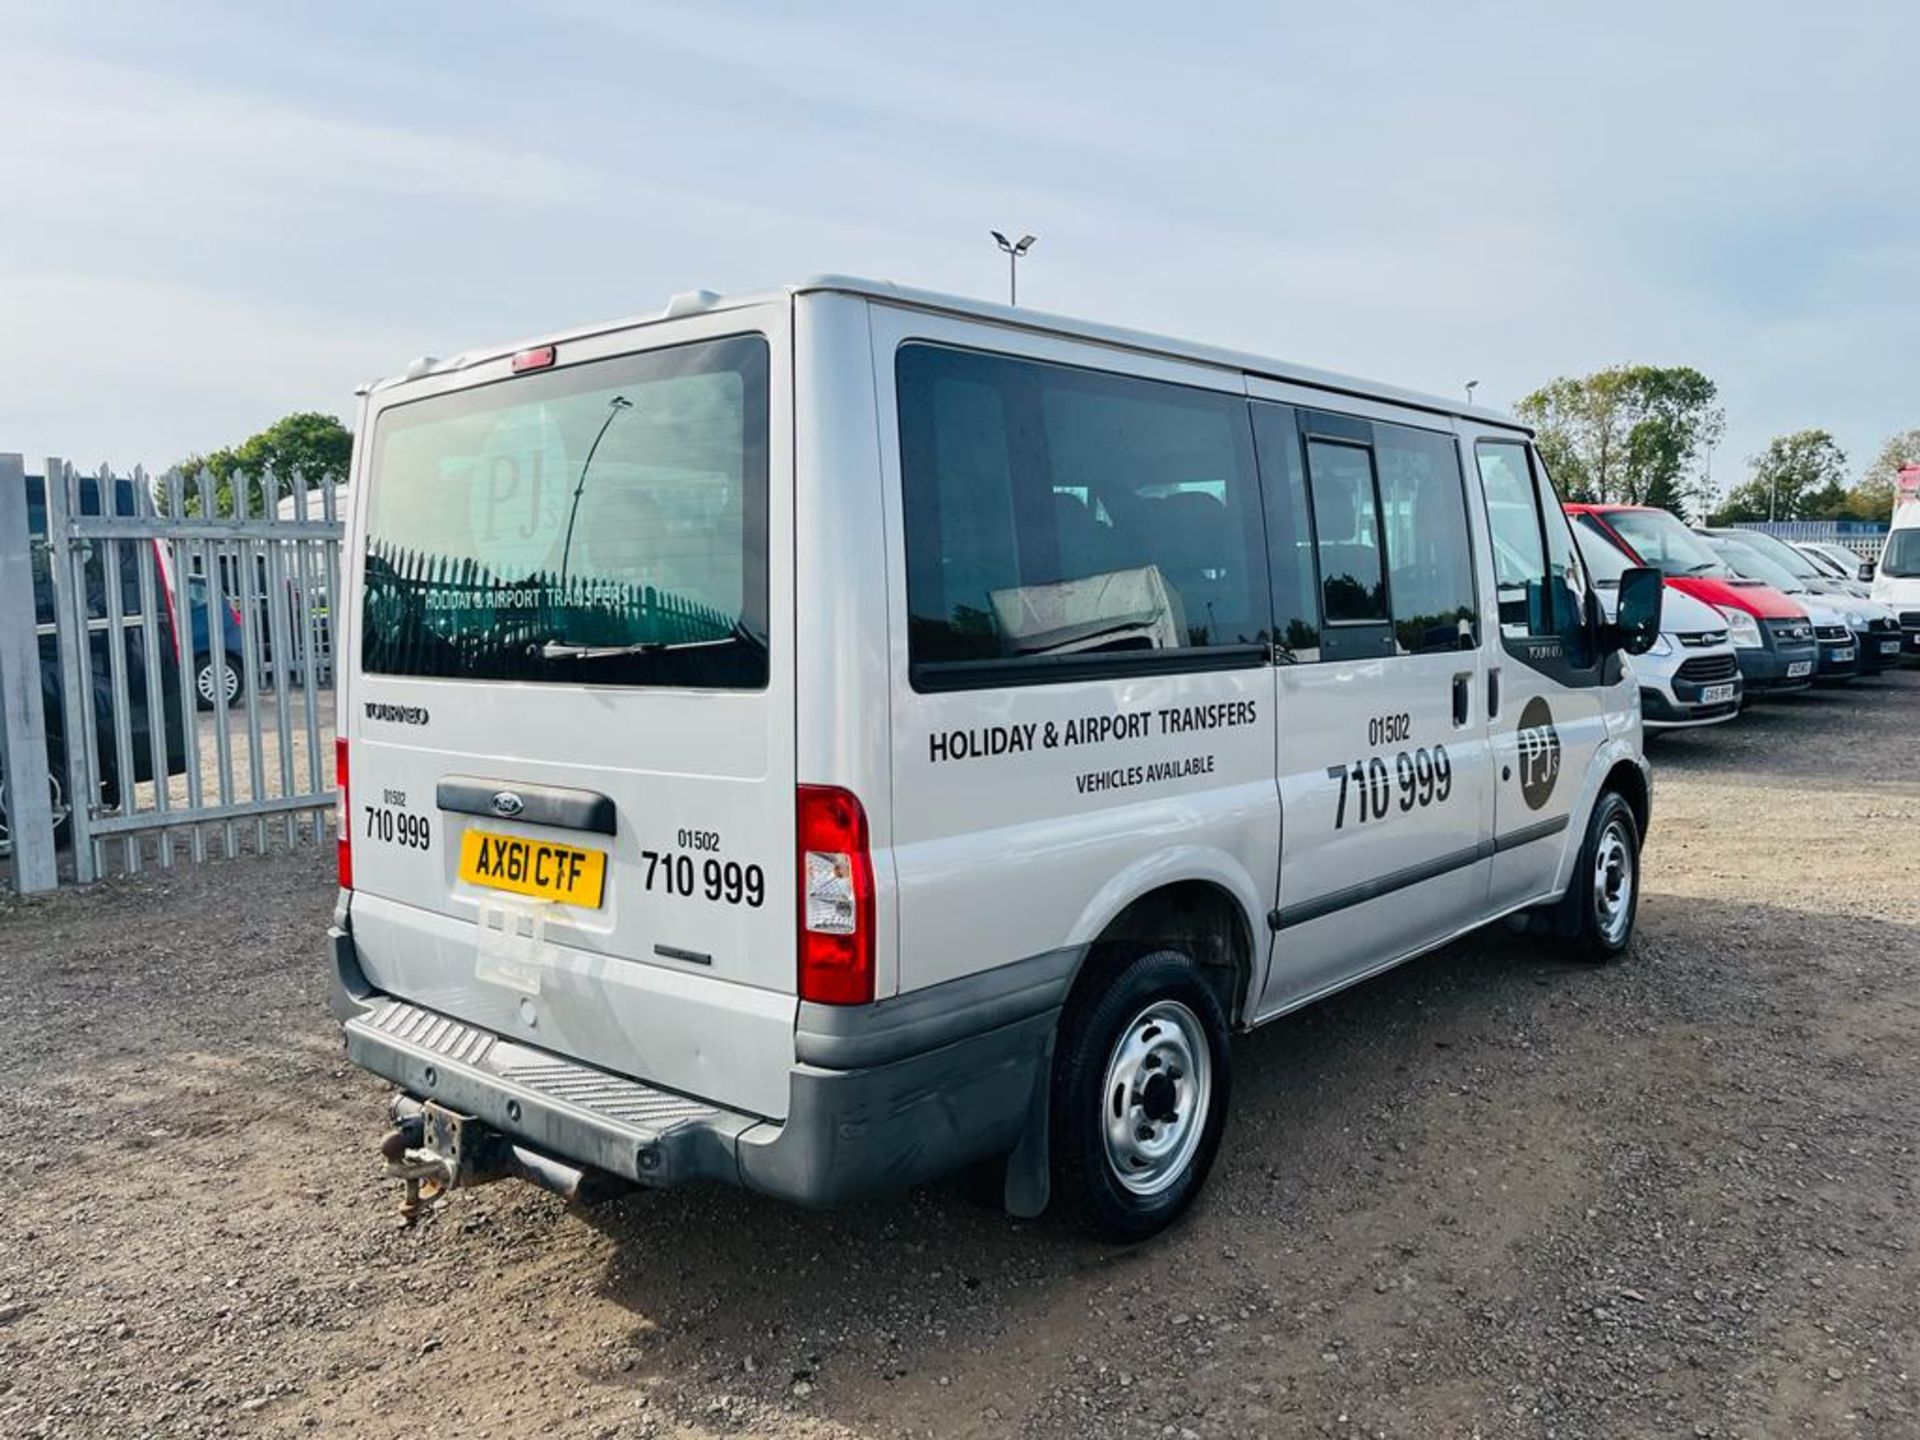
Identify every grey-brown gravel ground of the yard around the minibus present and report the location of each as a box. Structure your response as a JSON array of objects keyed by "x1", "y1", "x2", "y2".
[{"x1": 0, "y1": 670, "x2": 1920, "y2": 1440}]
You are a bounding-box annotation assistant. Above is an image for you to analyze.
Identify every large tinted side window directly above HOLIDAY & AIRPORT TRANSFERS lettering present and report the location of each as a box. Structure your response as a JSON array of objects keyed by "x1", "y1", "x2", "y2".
[{"x1": 895, "y1": 344, "x2": 1267, "y2": 678}]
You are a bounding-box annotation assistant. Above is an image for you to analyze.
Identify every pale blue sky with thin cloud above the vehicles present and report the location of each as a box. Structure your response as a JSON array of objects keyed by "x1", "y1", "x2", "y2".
[{"x1": 0, "y1": 0, "x2": 1920, "y2": 484}]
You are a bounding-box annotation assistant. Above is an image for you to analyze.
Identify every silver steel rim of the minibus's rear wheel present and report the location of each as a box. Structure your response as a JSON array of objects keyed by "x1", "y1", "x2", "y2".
[{"x1": 1100, "y1": 1000, "x2": 1213, "y2": 1196}]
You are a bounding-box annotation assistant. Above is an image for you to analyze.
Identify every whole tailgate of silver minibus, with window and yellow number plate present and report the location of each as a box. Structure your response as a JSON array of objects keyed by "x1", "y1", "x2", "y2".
[{"x1": 340, "y1": 301, "x2": 795, "y2": 1117}]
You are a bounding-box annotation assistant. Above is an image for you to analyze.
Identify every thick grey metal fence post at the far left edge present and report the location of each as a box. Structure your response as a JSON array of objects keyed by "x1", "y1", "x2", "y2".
[{"x1": 0, "y1": 455, "x2": 60, "y2": 895}]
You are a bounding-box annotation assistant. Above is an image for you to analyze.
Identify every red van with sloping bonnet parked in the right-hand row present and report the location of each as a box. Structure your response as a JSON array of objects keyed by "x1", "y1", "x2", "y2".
[{"x1": 1567, "y1": 505, "x2": 1820, "y2": 699}]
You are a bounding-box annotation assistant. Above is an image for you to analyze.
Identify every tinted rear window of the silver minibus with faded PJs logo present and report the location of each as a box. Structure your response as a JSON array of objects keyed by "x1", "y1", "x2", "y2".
[{"x1": 361, "y1": 336, "x2": 768, "y2": 689}]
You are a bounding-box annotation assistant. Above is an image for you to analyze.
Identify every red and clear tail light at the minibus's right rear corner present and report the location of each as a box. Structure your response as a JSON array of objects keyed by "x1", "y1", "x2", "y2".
[{"x1": 799, "y1": 785, "x2": 874, "y2": 1004}]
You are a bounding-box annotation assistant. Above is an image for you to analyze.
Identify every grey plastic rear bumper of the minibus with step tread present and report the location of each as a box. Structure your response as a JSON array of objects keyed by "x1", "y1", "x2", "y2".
[{"x1": 328, "y1": 916, "x2": 1069, "y2": 1206}]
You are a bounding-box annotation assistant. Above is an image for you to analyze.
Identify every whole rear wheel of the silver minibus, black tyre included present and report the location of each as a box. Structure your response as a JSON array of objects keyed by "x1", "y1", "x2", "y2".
[{"x1": 1050, "y1": 950, "x2": 1231, "y2": 1242}]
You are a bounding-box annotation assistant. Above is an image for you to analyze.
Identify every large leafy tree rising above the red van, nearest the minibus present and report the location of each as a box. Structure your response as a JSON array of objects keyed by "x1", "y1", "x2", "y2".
[{"x1": 1515, "y1": 365, "x2": 1726, "y2": 513}]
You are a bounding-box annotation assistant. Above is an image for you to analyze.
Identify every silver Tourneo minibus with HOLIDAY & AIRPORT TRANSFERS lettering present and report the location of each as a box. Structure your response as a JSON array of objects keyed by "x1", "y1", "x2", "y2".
[{"x1": 332, "y1": 278, "x2": 1661, "y2": 1238}]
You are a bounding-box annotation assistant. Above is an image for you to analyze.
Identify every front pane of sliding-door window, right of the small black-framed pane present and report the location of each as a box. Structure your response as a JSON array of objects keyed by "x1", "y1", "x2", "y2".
[{"x1": 1373, "y1": 424, "x2": 1480, "y2": 655}]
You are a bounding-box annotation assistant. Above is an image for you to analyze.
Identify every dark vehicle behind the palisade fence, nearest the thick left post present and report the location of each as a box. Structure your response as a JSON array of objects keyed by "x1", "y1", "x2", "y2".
[{"x1": 0, "y1": 474, "x2": 186, "y2": 856}]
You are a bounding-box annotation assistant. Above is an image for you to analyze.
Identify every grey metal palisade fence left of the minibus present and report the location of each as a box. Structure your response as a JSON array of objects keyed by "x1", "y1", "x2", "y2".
[{"x1": 0, "y1": 455, "x2": 344, "y2": 893}]
